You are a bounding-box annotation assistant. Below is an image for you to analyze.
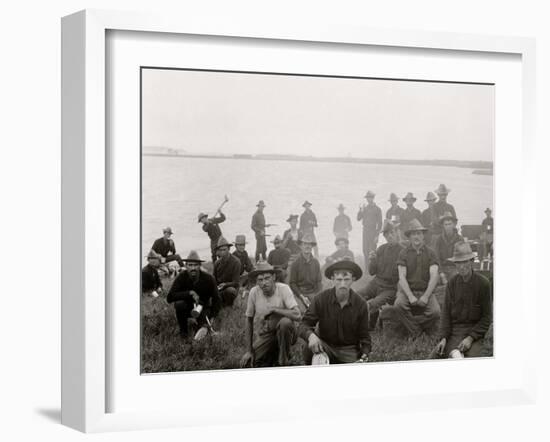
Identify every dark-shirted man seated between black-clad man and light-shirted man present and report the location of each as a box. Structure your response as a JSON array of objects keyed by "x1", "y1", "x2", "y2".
[{"x1": 214, "y1": 236, "x2": 241, "y2": 307}]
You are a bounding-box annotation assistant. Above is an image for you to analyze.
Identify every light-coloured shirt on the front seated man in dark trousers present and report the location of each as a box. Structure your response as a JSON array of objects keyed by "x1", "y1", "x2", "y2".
[{"x1": 245, "y1": 282, "x2": 298, "y2": 333}]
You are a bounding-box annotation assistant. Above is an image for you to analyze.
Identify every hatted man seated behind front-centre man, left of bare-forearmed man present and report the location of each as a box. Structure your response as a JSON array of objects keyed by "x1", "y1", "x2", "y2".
[{"x1": 361, "y1": 220, "x2": 403, "y2": 330}]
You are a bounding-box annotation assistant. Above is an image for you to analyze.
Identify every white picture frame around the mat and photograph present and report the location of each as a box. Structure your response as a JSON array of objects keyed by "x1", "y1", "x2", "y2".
[{"x1": 62, "y1": 10, "x2": 536, "y2": 432}]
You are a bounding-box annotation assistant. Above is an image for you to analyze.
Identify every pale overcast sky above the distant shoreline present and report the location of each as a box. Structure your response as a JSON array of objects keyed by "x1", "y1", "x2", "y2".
[{"x1": 142, "y1": 69, "x2": 494, "y2": 161}]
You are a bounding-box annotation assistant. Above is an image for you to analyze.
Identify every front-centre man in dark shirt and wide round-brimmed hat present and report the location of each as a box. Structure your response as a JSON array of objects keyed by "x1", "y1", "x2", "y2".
[{"x1": 299, "y1": 260, "x2": 371, "y2": 365}]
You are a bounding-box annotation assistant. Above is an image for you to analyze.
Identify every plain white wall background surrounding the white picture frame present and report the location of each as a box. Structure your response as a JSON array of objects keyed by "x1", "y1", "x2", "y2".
[{"x1": 0, "y1": 0, "x2": 550, "y2": 442}]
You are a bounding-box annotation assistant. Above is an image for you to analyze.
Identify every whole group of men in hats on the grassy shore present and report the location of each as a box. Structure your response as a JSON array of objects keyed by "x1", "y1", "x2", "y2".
[{"x1": 142, "y1": 184, "x2": 493, "y2": 366}]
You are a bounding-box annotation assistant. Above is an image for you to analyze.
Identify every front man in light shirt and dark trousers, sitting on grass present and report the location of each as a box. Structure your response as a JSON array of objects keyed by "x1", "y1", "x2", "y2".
[{"x1": 241, "y1": 262, "x2": 301, "y2": 367}]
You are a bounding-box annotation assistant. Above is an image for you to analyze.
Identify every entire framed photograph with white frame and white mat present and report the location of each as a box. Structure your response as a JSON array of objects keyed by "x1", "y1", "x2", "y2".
[{"x1": 62, "y1": 11, "x2": 535, "y2": 432}]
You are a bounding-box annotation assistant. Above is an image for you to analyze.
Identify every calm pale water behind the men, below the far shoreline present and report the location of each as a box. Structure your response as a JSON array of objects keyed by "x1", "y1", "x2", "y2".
[{"x1": 142, "y1": 156, "x2": 493, "y2": 259}]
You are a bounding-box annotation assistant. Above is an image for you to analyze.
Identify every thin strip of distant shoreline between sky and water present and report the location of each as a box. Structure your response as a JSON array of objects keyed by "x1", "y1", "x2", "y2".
[{"x1": 143, "y1": 152, "x2": 493, "y2": 173}]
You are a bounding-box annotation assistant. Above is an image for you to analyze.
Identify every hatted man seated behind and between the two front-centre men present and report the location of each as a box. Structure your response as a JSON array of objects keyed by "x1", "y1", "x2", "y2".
[{"x1": 289, "y1": 234, "x2": 322, "y2": 309}]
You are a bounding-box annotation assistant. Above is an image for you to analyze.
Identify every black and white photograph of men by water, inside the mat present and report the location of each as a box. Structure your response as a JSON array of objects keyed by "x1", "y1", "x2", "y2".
[{"x1": 141, "y1": 67, "x2": 495, "y2": 374}]
